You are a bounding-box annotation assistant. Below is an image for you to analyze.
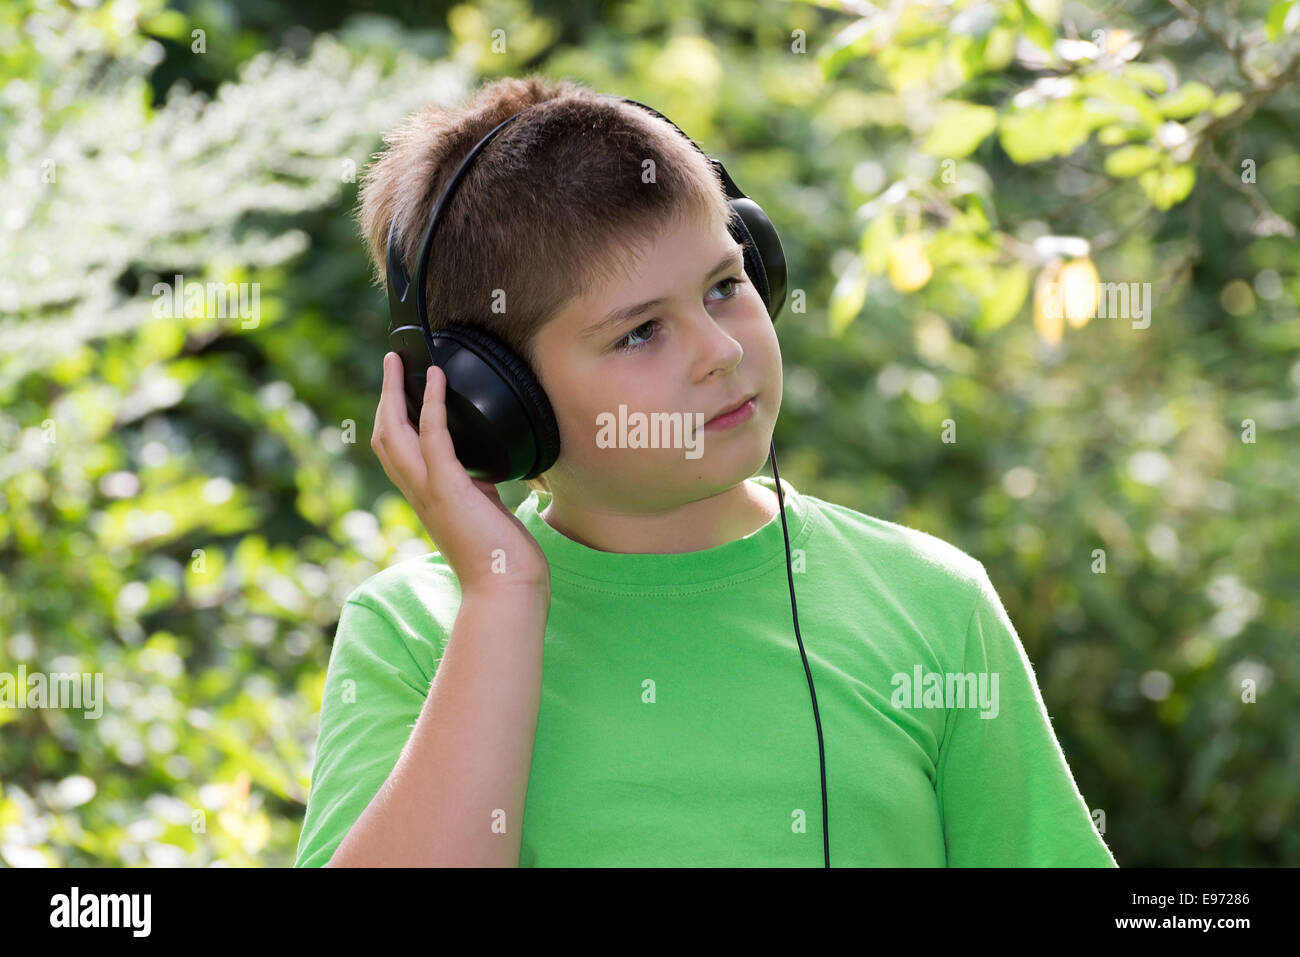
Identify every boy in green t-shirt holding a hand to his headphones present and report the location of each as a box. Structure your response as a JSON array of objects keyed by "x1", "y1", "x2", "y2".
[{"x1": 296, "y1": 75, "x2": 1115, "y2": 867}]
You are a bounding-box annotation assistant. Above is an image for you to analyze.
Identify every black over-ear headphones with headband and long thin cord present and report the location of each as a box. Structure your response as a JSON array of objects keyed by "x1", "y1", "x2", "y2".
[{"x1": 385, "y1": 96, "x2": 831, "y2": 867}]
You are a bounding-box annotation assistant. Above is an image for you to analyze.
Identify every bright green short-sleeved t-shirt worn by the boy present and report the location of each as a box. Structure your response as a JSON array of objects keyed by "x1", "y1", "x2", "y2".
[{"x1": 295, "y1": 476, "x2": 1115, "y2": 867}]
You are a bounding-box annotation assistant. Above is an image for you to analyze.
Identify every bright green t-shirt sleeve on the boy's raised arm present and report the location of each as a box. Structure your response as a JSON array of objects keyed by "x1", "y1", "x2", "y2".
[{"x1": 294, "y1": 598, "x2": 433, "y2": 867}]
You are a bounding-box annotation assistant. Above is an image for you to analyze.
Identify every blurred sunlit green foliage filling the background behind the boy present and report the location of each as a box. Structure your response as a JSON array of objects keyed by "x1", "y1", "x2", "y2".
[{"x1": 0, "y1": 0, "x2": 1300, "y2": 866}]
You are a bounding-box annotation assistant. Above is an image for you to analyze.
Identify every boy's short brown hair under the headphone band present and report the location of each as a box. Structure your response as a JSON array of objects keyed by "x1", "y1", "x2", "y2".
[{"x1": 358, "y1": 73, "x2": 731, "y2": 492}]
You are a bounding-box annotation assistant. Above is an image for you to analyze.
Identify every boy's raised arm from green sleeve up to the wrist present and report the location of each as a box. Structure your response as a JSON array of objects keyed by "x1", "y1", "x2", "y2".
[{"x1": 296, "y1": 589, "x2": 549, "y2": 867}]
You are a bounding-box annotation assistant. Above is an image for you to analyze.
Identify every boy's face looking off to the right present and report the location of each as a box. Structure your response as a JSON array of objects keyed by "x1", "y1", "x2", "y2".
[{"x1": 534, "y1": 213, "x2": 781, "y2": 512}]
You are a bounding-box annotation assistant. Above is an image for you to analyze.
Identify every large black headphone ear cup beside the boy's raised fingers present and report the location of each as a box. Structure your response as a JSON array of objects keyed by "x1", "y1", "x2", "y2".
[{"x1": 433, "y1": 324, "x2": 560, "y2": 484}]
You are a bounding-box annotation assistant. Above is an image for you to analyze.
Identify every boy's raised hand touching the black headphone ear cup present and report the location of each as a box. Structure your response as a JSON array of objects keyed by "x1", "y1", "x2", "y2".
[{"x1": 371, "y1": 352, "x2": 550, "y2": 593}]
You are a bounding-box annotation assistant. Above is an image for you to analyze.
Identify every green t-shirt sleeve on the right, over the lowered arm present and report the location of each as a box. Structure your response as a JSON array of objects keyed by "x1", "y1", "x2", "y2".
[{"x1": 935, "y1": 564, "x2": 1118, "y2": 867}]
